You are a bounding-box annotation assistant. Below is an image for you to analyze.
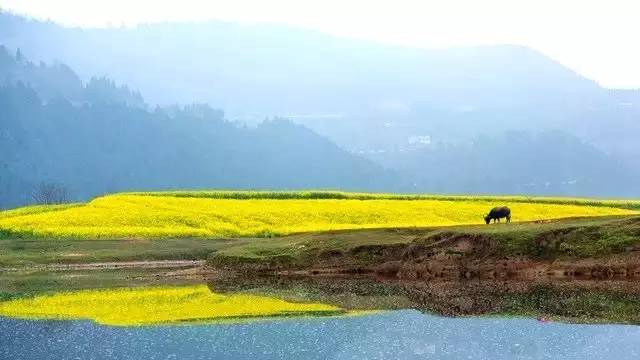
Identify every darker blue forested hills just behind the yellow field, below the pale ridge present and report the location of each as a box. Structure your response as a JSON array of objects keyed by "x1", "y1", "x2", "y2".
[{"x1": 0, "y1": 41, "x2": 640, "y2": 207}]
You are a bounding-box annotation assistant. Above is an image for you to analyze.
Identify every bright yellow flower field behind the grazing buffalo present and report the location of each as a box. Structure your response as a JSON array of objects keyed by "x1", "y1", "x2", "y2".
[{"x1": 0, "y1": 194, "x2": 637, "y2": 238}]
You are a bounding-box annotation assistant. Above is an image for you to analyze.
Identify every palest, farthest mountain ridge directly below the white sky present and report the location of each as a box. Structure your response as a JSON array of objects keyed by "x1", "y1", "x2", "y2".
[{"x1": 0, "y1": 13, "x2": 640, "y2": 156}]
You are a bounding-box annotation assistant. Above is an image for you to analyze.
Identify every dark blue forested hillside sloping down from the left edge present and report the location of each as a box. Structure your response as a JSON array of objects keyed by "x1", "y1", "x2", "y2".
[{"x1": 0, "y1": 52, "x2": 391, "y2": 207}]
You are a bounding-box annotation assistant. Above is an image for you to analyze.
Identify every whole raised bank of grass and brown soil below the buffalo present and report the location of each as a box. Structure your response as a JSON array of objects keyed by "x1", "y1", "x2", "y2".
[{"x1": 208, "y1": 216, "x2": 640, "y2": 281}]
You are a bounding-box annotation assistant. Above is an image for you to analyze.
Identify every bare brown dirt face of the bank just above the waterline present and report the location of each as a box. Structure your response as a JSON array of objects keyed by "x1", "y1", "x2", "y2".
[{"x1": 296, "y1": 236, "x2": 640, "y2": 280}]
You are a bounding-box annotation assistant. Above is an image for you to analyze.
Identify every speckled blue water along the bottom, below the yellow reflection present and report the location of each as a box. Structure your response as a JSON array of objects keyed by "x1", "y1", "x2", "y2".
[{"x1": 0, "y1": 310, "x2": 640, "y2": 360}]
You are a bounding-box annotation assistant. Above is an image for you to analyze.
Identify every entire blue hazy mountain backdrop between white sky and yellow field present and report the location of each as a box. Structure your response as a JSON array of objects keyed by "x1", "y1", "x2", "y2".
[{"x1": 0, "y1": 13, "x2": 640, "y2": 208}]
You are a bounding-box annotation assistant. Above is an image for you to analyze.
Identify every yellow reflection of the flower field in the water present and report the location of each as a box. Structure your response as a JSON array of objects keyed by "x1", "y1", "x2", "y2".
[{"x1": 0, "y1": 285, "x2": 344, "y2": 325}]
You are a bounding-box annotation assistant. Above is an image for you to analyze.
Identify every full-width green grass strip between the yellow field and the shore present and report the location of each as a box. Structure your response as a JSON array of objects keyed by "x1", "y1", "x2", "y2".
[{"x1": 0, "y1": 216, "x2": 640, "y2": 270}]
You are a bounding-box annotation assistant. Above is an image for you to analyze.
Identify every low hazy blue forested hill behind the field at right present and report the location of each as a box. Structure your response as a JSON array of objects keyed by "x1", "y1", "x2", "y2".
[{"x1": 371, "y1": 131, "x2": 640, "y2": 197}]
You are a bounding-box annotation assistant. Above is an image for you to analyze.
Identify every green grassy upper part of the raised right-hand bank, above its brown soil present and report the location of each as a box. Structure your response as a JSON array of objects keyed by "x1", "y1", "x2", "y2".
[{"x1": 210, "y1": 216, "x2": 640, "y2": 267}]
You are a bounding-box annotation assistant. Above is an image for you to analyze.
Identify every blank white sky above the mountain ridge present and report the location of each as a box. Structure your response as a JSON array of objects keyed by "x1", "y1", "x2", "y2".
[{"x1": 0, "y1": 0, "x2": 640, "y2": 87}]
